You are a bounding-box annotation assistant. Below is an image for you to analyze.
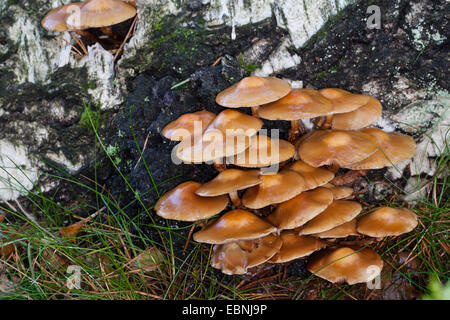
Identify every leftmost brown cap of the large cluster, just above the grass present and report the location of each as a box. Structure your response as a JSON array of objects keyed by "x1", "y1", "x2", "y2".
[{"x1": 155, "y1": 181, "x2": 228, "y2": 221}]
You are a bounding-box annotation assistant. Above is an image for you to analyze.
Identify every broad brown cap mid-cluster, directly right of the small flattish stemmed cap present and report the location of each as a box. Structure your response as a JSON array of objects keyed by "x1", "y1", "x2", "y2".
[{"x1": 242, "y1": 170, "x2": 305, "y2": 209}]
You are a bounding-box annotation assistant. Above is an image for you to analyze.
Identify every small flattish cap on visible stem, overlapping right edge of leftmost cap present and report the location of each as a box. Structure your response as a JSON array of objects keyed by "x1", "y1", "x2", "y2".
[{"x1": 195, "y1": 169, "x2": 262, "y2": 197}]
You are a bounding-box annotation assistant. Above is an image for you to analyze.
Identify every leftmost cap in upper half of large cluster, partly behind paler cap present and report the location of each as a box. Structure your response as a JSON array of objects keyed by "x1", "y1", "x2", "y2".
[{"x1": 162, "y1": 110, "x2": 216, "y2": 141}]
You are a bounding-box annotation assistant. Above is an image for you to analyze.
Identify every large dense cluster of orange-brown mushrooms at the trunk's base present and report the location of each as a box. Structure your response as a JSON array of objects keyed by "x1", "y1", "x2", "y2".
[{"x1": 155, "y1": 77, "x2": 417, "y2": 284}]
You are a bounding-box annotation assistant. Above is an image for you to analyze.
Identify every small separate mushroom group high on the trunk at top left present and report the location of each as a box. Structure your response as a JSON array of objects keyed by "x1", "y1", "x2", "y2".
[{"x1": 41, "y1": 0, "x2": 136, "y2": 57}]
